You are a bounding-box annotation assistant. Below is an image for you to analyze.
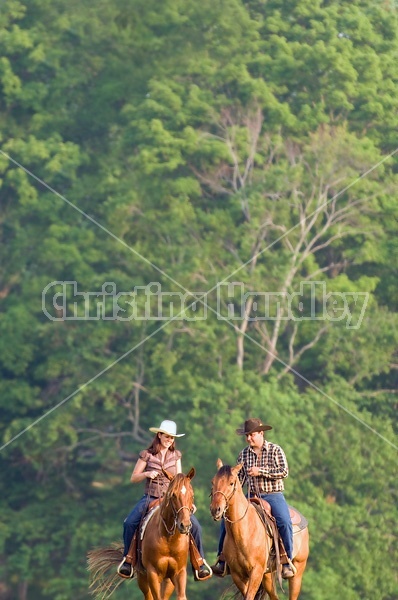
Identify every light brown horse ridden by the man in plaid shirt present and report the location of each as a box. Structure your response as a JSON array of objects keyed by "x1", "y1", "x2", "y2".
[{"x1": 210, "y1": 459, "x2": 309, "y2": 600}]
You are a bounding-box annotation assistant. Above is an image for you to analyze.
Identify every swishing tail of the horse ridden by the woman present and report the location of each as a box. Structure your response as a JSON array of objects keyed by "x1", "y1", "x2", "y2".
[{"x1": 87, "y1": 543, "x2": 123, "y2": 600}]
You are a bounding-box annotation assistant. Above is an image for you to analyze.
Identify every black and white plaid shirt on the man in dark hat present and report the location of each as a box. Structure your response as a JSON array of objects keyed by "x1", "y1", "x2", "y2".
[{"x1": 238, "y1": 440, "x2": 289, "y2": 496}]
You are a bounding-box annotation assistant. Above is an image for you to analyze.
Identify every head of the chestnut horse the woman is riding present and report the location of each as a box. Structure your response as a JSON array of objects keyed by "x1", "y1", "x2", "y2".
[{"x1": 162, "y1": 467, "x2": 195, "y2": 534}]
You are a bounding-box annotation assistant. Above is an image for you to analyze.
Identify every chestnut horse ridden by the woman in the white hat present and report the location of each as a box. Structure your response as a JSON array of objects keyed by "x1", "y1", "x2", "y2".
[{"x1": 88, "y1": 468, "x2": 195, "y2": 600}]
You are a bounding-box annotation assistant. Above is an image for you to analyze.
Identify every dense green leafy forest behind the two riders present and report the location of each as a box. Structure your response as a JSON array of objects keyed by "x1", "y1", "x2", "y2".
[{"x1": 0, "y1": 0, "x2": 398, "y2": 600}]
